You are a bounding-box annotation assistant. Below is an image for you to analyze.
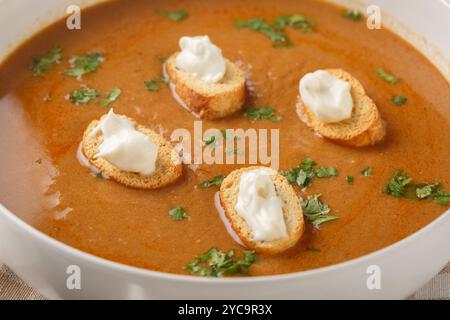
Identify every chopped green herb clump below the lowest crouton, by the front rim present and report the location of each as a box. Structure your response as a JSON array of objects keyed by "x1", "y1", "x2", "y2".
[{"x1": 186, "y1": 248, "x2": 256, "y2": 277}]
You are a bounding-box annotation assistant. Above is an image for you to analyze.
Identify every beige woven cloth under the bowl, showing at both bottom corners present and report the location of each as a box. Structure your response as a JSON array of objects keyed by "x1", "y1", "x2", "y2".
[{"x1": 0, "y1": 263, "x2": 450, "y2": 300}]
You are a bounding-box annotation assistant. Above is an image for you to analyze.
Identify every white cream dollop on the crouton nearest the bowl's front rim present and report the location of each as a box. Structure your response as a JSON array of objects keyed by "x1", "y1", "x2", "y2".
[{"x1": 235, "y1": 169, "x2": 288, "y2": 241}]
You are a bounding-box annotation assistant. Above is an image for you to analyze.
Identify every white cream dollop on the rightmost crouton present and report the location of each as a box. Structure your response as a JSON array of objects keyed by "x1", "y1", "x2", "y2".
[{"x1": 300, "y1": 70, "x2": 353, "y2": 123}]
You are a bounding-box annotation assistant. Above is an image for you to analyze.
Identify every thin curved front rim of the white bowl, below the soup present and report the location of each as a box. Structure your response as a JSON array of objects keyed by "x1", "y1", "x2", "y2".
[{"x1": 0, "y1": 203, "x2": 450, "y2": 285}]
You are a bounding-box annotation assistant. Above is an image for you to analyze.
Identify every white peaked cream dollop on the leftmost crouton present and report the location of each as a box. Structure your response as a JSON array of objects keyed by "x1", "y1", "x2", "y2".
[{"x1": 91, "y1": 109, "x2": 158, "y2": 175}]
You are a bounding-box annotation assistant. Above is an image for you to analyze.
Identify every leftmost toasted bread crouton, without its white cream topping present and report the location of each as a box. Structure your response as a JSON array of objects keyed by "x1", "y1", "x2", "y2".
[{"x1": 81, "y1": 114, "x2": 182, "y2": 189}]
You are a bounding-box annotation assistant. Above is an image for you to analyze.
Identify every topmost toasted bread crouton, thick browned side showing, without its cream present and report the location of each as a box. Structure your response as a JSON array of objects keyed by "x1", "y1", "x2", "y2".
[{"x1": 165, "y1": 53, "x2": 246, "y2": 120}]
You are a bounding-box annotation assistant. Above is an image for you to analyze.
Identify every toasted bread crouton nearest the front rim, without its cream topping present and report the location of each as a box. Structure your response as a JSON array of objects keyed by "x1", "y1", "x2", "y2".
[{"x1": 220, "y1": 167, "x2": 304, "y2": 254}]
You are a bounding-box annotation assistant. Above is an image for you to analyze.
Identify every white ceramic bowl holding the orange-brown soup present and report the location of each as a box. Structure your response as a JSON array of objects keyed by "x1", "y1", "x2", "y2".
[{"x1": 0, "y1": 0, "x2": 450, "y2": 299}]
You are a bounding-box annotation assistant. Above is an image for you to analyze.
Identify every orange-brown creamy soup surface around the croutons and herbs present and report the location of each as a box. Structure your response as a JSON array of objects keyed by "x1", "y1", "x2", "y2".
[{"x1": 0, "y1": 0, "x2": 450, "y2": 275}]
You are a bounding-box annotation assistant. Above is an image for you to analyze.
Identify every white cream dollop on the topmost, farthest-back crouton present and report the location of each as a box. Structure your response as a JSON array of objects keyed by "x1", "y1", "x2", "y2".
[{"x1": 176, "y1": 36, "x2": 226, "y2": 83}]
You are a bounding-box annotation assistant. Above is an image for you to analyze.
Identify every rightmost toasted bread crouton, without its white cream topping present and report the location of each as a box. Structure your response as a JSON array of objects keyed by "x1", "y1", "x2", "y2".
[{"x1": 297, "y1": 69, "x2": 386, "y2": 147}]
